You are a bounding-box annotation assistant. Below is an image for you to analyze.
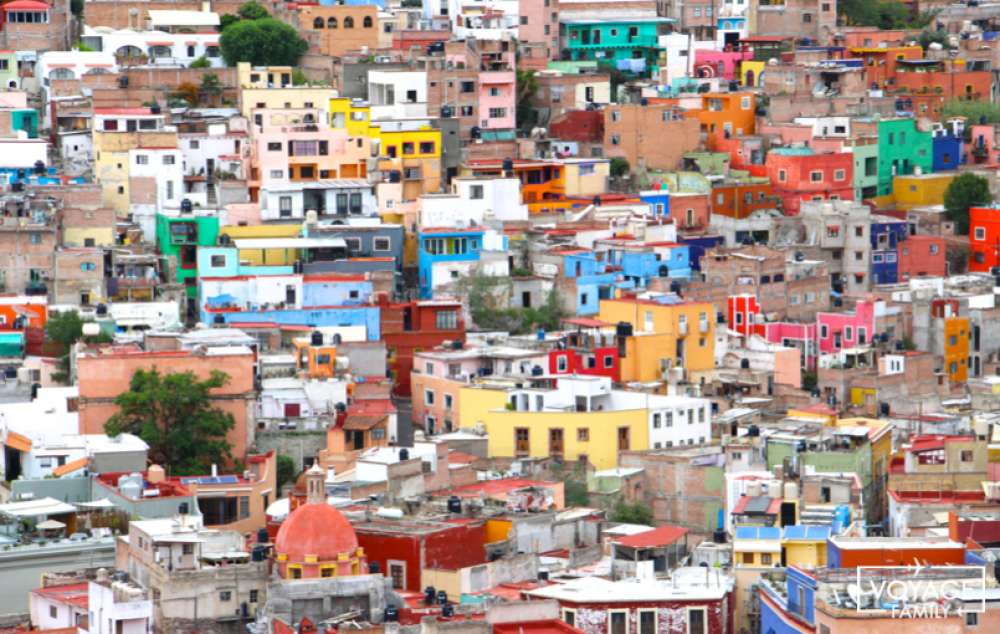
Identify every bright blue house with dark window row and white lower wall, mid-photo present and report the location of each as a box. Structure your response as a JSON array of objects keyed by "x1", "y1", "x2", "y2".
[{"x1": 417, "y1": 228, "x2": 490, "y2": 299}]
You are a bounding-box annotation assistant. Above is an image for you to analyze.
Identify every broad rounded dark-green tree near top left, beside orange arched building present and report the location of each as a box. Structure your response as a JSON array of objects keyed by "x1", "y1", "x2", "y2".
[{"x1": 219, "y1": 18, "x2": 309, "y2": 66}]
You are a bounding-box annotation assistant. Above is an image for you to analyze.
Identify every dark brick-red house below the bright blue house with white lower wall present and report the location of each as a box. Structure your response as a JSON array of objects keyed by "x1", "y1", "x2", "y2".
[{"x1": 378, "y1": 294, "x2": 465, "y2": 396}]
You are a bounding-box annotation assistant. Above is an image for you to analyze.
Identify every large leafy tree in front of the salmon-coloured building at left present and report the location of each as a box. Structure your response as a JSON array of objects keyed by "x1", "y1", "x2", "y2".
[{"x1": 104, "y1": 368, "x2": 235, "y2": 475}]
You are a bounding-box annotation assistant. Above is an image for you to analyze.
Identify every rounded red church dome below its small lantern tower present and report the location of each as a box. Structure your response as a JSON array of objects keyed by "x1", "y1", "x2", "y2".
[{"x1": 274, "y1": 504, "x2": 358, "y2": 563}]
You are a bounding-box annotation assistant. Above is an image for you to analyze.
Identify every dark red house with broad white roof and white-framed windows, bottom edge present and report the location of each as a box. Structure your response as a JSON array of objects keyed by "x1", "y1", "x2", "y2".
[{"x1": 524, "y1": 567, "x2": 735, "y2": 634}]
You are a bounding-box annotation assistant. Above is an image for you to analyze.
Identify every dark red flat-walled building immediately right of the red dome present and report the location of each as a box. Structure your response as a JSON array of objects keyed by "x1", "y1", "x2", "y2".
[{"x1": 354, "y1": 519, "x2": 486, "y2": 599}]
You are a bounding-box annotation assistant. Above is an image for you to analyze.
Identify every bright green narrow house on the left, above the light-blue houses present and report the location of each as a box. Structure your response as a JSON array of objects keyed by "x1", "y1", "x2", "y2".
[{"x1": 156, "y1": 213, "x2": 219, "y2": 301}]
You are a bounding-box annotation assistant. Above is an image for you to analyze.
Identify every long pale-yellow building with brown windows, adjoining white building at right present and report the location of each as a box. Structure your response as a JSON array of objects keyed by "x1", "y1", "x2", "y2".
[{"x1": 459, "y1": 376, "x2": 649, "y2": 470}]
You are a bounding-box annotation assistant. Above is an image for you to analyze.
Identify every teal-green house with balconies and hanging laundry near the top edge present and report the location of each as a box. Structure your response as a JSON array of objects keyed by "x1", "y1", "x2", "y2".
[{"x1": 561, "y1": 18, "x2": 674, "y2": 77}]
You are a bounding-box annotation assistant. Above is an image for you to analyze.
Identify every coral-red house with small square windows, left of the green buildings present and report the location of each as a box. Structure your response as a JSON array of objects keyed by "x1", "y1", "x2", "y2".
[{"x1": 766, "y1": 148, "x2": 854, "y2": 216}]
